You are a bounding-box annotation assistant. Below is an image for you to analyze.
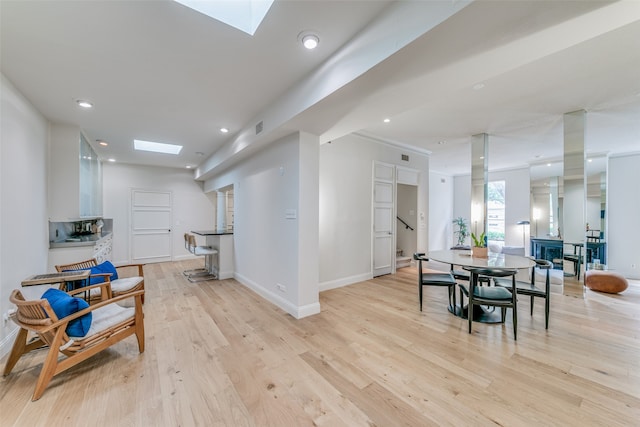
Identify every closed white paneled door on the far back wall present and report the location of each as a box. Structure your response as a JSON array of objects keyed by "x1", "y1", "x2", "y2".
[{"x1": 131, "y1": 190, "x2": 172, "y2": 263}]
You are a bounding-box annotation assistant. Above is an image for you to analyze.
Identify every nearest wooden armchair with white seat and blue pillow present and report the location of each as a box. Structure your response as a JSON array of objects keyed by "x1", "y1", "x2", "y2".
[{"x1": 3, "y1": 282, "x2": 144, "y2": 401}]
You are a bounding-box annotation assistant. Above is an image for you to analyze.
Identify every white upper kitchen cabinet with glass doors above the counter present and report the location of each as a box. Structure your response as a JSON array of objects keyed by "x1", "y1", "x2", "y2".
[{"x1": 49, "y1": 124, "x2": 102, "y2": 221}]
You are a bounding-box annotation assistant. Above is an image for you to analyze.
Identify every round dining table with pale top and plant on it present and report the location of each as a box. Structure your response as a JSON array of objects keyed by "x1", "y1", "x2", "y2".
[{"x1": 427, "y1": 249, "x2": 536, "y2": 323}]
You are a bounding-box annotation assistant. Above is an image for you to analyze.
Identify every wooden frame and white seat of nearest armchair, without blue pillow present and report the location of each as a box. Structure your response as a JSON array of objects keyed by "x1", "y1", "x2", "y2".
[{"x1": 3, "y1": 282, "x2": 144, "y2": 401}]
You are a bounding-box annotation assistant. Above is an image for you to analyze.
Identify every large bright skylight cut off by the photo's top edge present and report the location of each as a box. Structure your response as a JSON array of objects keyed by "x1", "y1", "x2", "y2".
[{"x1": 174, "y1": 0, "x2": 274, "y2": 35}]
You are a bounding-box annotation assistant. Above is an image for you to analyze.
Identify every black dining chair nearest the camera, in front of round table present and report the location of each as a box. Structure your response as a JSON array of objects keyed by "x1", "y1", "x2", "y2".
[{"x1": 458, "y1": 267, "x2": 518, "y2": 340}]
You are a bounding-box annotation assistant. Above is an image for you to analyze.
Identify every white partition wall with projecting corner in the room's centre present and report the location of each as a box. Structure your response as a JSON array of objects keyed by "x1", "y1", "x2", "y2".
[{"x1": 205, "y1": 133, "x2": 320, "y2": 318}]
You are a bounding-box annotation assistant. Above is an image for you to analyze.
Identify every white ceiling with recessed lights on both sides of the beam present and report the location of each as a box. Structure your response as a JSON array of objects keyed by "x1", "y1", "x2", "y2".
[{"x1": 0, "y1": 0, "x2": 640, "y2": 174}]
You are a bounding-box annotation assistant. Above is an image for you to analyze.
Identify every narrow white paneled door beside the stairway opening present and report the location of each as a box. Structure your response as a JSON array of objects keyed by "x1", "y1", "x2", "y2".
[{"x1": 373, "y1": 162, "x2": 396, "y2": 277}]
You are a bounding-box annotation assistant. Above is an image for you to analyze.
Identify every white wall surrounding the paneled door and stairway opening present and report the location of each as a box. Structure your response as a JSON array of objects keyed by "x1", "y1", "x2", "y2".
[{"x1": 319, "y1": 135, "x2": 429, "y2": 290}]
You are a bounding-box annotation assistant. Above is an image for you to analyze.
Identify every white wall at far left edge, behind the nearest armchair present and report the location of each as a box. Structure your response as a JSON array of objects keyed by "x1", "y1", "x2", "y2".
[{"x1": 0, "y1": 75, "x2": 49, "y2": 357}]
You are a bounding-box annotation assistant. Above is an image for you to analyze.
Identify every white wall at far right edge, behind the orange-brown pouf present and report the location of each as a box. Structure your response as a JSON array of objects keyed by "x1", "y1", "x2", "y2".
[{"x1": 605, "y1": 153, "x2": 640, "y2": 279}]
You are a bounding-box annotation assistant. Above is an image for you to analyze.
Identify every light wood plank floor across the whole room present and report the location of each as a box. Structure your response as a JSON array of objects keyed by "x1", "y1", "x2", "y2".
[{"x1": 0, "y1": 262, "x2": 640, "y2": 427}]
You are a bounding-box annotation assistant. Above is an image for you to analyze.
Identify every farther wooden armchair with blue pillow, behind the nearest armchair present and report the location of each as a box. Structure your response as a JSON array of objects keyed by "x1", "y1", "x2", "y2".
[{"x1": 56, "y1": 258, "x2": 144, "y2": 303}]
